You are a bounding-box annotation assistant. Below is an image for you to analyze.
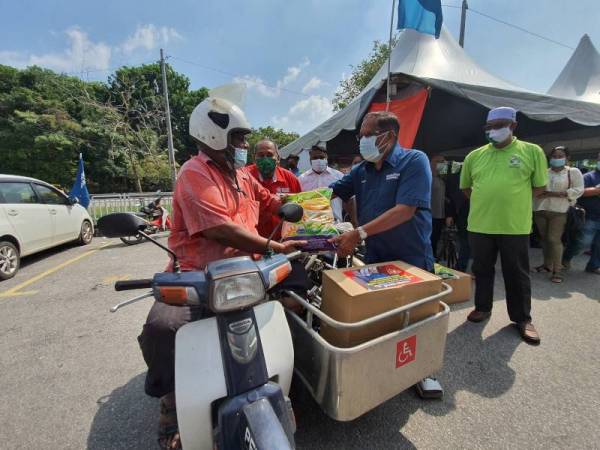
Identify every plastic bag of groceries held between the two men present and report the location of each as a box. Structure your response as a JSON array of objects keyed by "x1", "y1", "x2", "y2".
[{"x1": 281, "y1": 188, "x2": 339, "y2": 252}]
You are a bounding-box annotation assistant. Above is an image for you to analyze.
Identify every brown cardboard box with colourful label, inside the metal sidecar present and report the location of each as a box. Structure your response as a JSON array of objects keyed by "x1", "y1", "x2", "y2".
[{"x1": 321, "y1": 261, "x2": 442, "y2": 347}]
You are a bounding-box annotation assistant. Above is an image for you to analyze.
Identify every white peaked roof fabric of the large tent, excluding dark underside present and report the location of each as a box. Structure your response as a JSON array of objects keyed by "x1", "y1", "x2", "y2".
[{"x1": 281, "y1": 27, "x2": 600, "y2": 157}]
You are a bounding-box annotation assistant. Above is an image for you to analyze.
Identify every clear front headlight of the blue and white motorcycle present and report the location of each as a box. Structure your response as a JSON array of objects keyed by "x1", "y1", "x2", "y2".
[{"x1": 210, "y1": 272, "x2": 265, "y2": 312}]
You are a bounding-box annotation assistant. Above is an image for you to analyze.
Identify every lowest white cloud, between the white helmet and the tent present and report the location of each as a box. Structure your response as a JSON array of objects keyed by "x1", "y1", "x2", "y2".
[{"x1": 271, "y1": 95, "x2": 333, "y2": 133}]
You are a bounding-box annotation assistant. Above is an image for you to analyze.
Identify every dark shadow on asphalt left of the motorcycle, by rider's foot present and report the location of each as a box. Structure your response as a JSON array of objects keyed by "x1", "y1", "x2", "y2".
[{"x1": 87, "y1": 373, "x2": 158, "y2": 450}]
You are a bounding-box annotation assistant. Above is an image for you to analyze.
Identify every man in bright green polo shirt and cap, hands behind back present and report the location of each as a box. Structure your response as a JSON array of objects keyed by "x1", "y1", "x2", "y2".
[{"x1": 460, "y1": 107, "x2": 548, "y2": 344}]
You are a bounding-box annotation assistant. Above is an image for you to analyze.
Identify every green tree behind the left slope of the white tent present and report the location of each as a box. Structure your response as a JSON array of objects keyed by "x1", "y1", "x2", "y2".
[{"x1": 332, "y1": 36, "x2": 398, "y2": 111}]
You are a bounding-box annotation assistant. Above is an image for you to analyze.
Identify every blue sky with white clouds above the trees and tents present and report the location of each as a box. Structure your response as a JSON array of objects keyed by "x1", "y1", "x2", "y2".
[{"x1": 0, "y1": 0, "x2": 600, "y2": 134}]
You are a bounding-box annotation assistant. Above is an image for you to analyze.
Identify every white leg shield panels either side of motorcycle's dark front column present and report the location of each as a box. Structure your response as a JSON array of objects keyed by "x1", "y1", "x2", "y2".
[{"x1": 175, "y1": 301, "x2": 294, "y2": 450}]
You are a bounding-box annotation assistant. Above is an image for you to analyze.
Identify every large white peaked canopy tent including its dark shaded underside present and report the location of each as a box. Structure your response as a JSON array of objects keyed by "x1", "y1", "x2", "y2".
[{"x1": 281, "y1": 28, "x2": 600, "y2": 158}]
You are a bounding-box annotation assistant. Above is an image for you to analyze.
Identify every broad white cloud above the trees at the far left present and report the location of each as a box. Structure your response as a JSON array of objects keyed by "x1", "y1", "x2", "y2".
[{"x1": 0, "y1": 27, "x2": 112, "y2": 72}]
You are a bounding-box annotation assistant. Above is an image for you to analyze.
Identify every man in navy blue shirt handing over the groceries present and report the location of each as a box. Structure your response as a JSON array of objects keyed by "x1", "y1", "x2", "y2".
[{"x1": 330, "y1": 112, "x2": 433, "y2": 271}]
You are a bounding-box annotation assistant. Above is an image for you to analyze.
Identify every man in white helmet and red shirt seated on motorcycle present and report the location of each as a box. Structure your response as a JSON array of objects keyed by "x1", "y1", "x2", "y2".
[{"x1": 138, "y1": 97, "x2": 302, "y2": 448}]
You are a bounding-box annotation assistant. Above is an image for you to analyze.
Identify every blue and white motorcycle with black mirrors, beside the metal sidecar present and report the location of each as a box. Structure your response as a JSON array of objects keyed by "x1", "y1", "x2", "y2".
[{"x1": 98, "y1": 204, "x2": 303, "y2": 450}]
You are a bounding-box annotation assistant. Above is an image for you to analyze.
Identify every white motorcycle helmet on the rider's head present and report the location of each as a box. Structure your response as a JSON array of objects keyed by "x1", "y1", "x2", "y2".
[{"x1": 190, "y1": 97, "x2": 251, "y2": 151}]
